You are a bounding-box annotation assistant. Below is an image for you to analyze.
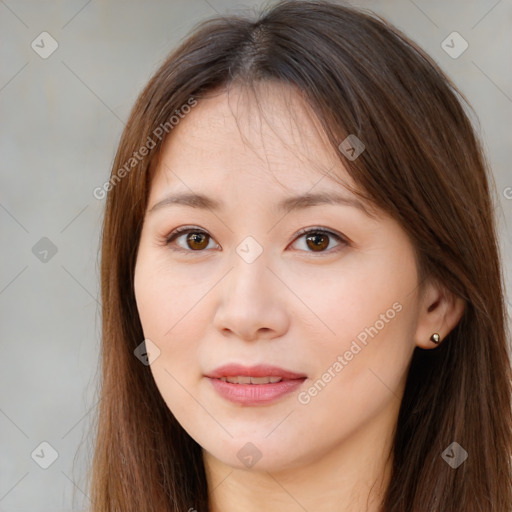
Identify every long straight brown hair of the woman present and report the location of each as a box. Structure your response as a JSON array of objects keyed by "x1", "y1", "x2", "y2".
[{"x1": 90, "y1": 1, "x2": 512, "y2": 512}]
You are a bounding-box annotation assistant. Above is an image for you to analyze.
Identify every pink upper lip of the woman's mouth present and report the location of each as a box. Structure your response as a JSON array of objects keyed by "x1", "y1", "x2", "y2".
[{"x1": 206, "y1": 363, "x2": 306, "y2": 384}]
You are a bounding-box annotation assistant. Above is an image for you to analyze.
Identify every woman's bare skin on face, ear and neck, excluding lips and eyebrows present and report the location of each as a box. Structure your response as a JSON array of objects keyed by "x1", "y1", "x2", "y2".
[{"x1": 134, "y1": 84, "x2": 463, "y2": 512}]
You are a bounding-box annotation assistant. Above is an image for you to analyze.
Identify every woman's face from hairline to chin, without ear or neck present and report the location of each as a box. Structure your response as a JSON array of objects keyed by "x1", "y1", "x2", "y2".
[{"x1": 135, "y1": 85, "x2": 419, "y2": 471}]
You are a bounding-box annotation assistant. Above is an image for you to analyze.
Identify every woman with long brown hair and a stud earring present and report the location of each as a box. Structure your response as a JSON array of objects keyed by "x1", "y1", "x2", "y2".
[{"x1": 86, "y1": 1, "x2": 512, "y2": 512}]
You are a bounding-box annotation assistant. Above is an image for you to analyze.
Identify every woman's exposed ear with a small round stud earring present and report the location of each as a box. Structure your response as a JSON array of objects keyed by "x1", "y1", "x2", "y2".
[{"x1": 414, "y1": 282, "x2": 466, "y2": 349}]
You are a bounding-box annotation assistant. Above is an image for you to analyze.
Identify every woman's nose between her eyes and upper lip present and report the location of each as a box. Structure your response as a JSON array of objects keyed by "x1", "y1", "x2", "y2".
[{"x1": 213, "y1": 251, "x2": 290, "y2": 341}]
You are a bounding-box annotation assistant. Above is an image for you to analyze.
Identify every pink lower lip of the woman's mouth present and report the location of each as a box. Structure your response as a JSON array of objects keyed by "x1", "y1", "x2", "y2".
[{"x1": 207, "y1": 377, "x2": 306, "y2": 405}]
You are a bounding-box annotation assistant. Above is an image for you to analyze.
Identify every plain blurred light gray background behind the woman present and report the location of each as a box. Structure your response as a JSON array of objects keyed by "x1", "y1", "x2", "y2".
[{"x1": 0, "y1": 0, "x2": 512, "y2": 512}]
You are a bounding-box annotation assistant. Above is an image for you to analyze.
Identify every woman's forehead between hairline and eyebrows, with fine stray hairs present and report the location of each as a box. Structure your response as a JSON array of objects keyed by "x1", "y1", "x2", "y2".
[{"x1": 152, "y1": 83, "x2": 360, "y2": 197}]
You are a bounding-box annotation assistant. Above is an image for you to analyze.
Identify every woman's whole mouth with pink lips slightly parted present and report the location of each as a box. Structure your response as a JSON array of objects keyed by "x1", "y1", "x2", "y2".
[{"x1": 205, "y1": 364, "x2": 307, "y2": 406}]
